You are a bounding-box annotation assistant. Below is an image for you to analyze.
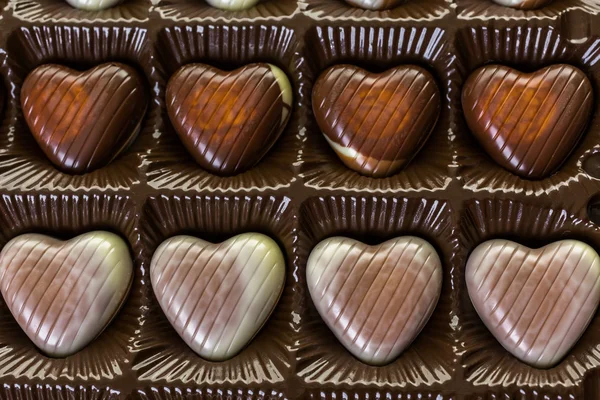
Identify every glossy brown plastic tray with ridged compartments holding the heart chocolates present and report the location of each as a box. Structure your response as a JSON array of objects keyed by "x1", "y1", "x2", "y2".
[{"x1": 0, "y1": 0, "x2": 600, "y2": 400}]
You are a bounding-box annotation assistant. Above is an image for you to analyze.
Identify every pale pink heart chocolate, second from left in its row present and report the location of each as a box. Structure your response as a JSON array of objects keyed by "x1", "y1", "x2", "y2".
[{"x1": 150, "y1": 233, "x2": 285, "y2": 361}]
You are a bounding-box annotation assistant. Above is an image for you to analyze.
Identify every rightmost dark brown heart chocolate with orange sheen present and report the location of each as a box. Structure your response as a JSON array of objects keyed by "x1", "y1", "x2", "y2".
[{"x1": 462, "y1": 64, "x2": 594, "y2": 179}]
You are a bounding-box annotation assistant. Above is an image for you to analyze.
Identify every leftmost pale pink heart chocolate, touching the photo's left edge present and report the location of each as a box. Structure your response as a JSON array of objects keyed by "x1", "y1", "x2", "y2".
[{"x1": 0, "y1": 231, "x2": 133, "y2": 357}]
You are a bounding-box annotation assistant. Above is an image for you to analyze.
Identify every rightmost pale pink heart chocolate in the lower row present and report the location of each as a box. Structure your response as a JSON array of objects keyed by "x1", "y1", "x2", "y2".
[{"x1": 465, "y1": 239, "x2": 600, "y2": 368}]
